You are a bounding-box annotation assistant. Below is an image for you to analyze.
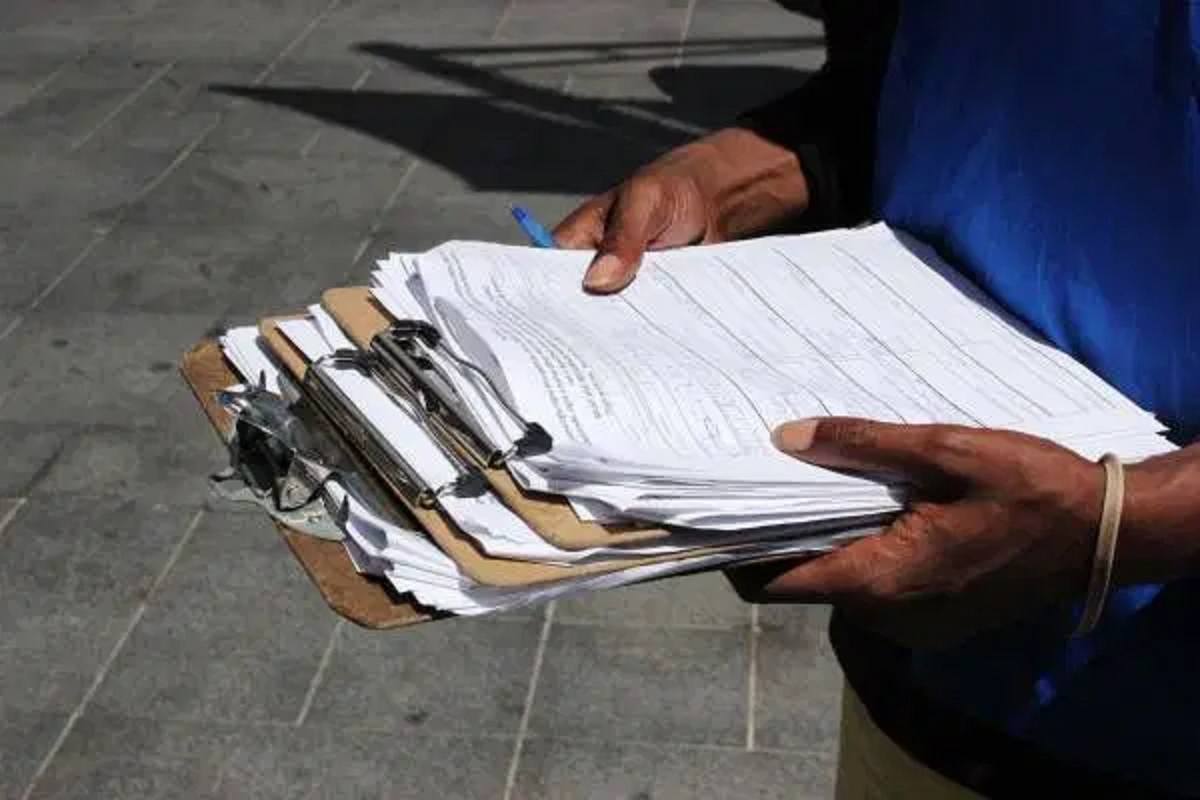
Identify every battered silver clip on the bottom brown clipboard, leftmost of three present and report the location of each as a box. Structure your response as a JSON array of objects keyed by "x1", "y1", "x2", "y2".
[{"x1": 209, "y1": 379, "x2": 343, "y2": 541}]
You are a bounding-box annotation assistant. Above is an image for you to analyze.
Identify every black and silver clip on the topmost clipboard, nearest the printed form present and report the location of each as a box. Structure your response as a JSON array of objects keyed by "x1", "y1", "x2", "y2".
[{"x1": 371, "y1": 319, "x2": 553, "y2": 468}]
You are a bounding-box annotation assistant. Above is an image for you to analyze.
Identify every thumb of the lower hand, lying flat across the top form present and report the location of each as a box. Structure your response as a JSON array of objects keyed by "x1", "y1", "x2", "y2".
[{"x1": 772, "y1": 416, "x2": 998, "y2": 487}]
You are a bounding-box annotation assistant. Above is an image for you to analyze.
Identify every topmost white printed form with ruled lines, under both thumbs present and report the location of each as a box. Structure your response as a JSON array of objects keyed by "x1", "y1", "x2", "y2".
[{"x1": 408, "y1": 227, "x2": 1160, "y2": 482}]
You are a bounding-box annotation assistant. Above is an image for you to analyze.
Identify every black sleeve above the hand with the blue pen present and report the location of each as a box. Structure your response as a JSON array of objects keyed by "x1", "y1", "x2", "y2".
[{"x1": 739, "y1": 0, "x2": 899, "y2": 229}]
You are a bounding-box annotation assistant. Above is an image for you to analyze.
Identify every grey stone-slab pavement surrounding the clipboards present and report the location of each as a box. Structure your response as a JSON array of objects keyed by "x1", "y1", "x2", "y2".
[{"x1": 0, "y1": 0, "x2": 840, "y2": 799}]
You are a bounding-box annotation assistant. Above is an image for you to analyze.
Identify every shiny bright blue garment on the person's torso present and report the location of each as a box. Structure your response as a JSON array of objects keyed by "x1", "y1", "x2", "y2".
[{"x1": 875, "y1": 0, "x2": 1200, "y2": 793}]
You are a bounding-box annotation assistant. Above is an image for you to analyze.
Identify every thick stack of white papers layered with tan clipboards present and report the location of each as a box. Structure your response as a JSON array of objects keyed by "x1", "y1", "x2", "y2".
[{"x1": 208, "y1": 225, "x2": 1171, "y2": 614}]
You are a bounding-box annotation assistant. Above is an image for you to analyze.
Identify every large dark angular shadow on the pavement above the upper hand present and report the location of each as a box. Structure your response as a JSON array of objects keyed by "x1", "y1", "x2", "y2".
[{"x1": 210, "y1": 43, "x2": 806, "y2": 194}]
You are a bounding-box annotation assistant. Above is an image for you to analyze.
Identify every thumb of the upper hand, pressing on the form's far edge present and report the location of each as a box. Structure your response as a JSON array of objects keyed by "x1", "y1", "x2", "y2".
[{"x1": 583, "y1": 179, "x2": 667, "y2": 294}]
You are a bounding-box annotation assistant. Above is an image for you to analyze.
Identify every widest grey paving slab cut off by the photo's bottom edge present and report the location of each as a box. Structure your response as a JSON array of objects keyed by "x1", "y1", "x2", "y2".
[{"x1": 32, "y1": 712, "x2": 512, "y2": 800}]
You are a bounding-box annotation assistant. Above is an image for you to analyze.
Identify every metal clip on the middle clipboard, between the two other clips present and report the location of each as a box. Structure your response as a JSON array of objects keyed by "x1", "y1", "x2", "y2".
[{"x1": 304, "y1": 350, "x2": 488, "y2": 507}]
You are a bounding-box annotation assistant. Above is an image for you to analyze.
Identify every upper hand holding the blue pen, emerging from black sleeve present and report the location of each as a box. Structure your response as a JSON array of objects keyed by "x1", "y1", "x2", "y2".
[{"x1": 554, "y1": 128, "x2": 808, "y2": 294}]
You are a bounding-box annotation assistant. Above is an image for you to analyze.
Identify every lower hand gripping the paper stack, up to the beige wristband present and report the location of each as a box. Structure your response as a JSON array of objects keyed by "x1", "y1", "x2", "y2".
[{"x1": 730, "y1": 417, "x2": 1113, "y2": 646}]
